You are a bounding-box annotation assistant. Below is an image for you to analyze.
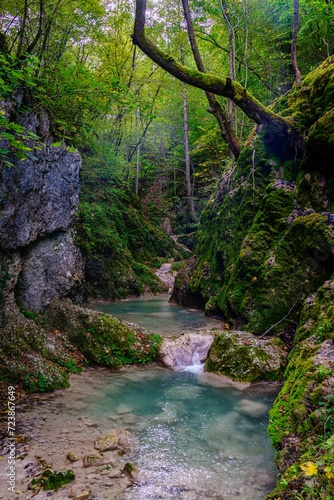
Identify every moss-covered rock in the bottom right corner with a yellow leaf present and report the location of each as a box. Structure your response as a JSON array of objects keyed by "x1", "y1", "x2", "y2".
[{"x1": 268, "y1": 281, "x2": 334, "y2": 500}]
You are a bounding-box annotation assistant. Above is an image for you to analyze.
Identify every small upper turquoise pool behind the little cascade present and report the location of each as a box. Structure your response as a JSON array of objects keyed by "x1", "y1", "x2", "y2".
[{"x1": 88, "y1": 295, "x2": 219, "y2": 336}]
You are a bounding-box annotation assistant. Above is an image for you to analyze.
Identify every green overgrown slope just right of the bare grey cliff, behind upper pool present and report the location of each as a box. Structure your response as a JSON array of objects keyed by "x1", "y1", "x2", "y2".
[{"x1": 76, "y1": 160, "x2": 185, "y2": 300}]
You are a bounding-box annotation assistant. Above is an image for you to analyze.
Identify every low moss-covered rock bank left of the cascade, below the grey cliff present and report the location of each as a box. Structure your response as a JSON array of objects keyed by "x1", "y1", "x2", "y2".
[{"x1": 0, "y1": 299, "x2": 162, "y2": 392}]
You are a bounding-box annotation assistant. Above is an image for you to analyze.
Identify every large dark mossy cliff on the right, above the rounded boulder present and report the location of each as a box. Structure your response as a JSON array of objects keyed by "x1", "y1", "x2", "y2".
[{"x1": 172, "y1": 57, "x2": 334, "y2": 342}]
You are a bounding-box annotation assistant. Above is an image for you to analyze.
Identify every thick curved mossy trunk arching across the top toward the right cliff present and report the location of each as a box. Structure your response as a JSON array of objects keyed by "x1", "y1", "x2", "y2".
[{"x1": 133, "y1": 0, "x2": 297, "y2": 148}]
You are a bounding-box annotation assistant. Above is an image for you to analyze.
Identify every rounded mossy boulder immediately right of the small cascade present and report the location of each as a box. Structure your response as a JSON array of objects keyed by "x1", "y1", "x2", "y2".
[{"x1": 205, "y1": 331, "x2": 287, "y2": 382}]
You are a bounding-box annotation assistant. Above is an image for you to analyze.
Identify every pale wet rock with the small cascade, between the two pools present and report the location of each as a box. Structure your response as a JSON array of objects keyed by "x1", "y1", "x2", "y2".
[{"x1": 160, "y1": 333, "x2": 214, "y2": 367}]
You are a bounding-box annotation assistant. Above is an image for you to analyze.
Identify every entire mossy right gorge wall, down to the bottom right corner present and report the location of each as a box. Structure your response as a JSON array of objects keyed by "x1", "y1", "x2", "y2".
[{"x1": 172, "y1": 57, "x2": 334, "y2": 500}]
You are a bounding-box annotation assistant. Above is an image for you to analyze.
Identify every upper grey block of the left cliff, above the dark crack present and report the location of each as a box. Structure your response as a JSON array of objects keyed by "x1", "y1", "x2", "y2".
[{"x1": 0, "y1": 147, "x2": 81, "y2": 250}]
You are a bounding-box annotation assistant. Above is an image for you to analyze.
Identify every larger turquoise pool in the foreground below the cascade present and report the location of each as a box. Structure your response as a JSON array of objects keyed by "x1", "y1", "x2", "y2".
[{"x1": 80, "y1": 367, "x2": 277, "y2": 500}]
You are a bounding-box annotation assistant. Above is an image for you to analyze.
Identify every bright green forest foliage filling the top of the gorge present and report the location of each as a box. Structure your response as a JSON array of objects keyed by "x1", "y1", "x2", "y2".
[{"x1": 0, "y1": 0, "x2": 334, "y2": 220}]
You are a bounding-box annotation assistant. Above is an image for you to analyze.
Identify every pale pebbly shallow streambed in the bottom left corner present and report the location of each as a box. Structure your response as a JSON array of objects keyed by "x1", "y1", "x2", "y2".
[{"x1": 0, "y1": 368, "x2": 145, "y2": 500}]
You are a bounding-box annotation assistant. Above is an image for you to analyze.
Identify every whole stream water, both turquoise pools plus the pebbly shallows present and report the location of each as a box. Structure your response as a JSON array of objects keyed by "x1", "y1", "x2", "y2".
[{"x1": 0, "y1": 296, "x2": 278, "y2": 500}]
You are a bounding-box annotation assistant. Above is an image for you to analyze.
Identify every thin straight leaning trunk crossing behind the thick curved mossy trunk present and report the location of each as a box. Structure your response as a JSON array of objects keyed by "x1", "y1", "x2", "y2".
[{"x1": 182, "y1": 0, "x2": 240, "y2": 158}]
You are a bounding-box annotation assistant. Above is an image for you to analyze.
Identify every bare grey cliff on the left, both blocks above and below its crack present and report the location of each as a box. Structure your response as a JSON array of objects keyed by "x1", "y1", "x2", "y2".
[{"x1": 0, "y1": 109, "x2": 83, "y2": 320}]
